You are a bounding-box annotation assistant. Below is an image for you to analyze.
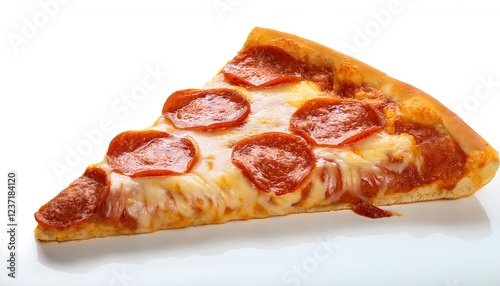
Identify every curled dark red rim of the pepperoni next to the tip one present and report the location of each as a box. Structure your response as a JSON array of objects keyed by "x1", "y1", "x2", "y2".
[{"x1": 106, "y1": 130, "x2": 198, "y2": 178}]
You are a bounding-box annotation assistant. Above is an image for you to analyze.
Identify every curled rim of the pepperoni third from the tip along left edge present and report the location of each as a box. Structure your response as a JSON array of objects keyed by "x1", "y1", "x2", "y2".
[{"x1": 162, "y1": 88, "x2": 250, "y2": 131}]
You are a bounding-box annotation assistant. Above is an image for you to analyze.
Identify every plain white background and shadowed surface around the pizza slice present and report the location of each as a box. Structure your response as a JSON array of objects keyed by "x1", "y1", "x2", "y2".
[{"x1": 0, "y1": 0, "x2": 500, "y2": 286}]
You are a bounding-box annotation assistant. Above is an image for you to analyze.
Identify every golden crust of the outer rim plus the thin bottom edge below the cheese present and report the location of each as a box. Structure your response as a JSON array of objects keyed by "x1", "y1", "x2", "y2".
[{"x1": 35, "y1": 27, "x2": 499, "y2": 241}]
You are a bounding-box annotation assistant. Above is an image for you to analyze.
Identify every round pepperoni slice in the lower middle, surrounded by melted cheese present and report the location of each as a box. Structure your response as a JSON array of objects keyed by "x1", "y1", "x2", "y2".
[{"x1": 231, "y1": 132, "x2": 315, "y2": 195}]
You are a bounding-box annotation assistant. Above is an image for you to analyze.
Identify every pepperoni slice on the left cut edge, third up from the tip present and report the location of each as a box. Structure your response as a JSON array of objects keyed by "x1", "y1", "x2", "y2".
[{"x1": 162, "y1": 88, "x2": 250, "y2": 131}]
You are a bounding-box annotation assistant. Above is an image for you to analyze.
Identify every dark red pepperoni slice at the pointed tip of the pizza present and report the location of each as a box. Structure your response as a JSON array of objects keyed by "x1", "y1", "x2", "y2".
[{"x1": 35, "y1": 166, "x2": 110, "y2": 230}]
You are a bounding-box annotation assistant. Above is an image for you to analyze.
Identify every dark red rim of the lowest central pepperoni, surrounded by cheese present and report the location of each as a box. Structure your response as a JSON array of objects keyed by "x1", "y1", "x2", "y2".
[{"x1": 231, "y1": 132, "x2": 316, "y2": 196}]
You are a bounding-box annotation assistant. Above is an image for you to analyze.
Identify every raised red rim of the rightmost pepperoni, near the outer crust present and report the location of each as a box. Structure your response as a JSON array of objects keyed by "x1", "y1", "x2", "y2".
[{"x1": 289, "y1": 97, "x2": 385, "y2": 147}]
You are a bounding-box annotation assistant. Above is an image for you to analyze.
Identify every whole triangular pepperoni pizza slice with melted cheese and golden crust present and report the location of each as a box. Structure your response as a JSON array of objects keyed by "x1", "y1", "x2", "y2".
[{"x1": 35, "y1": 28, "x2": 499, "y2": 241}]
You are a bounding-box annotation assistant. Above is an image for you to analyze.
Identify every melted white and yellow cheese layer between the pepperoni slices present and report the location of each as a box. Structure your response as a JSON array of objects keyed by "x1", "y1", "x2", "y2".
[{"x1": 98, "y1": 74, "x2": 421, "y2": 232}]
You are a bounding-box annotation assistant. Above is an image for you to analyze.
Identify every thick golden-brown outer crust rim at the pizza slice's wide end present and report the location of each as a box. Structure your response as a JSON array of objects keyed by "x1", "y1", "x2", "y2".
[{"x1": 244, "y1": 27, "x2": 499, "y2": 199}]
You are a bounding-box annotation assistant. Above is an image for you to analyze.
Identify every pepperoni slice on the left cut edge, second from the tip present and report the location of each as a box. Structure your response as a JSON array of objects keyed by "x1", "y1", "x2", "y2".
[{"x1": 107, "y1": 130, "x2": 196, "y2": 177}]
